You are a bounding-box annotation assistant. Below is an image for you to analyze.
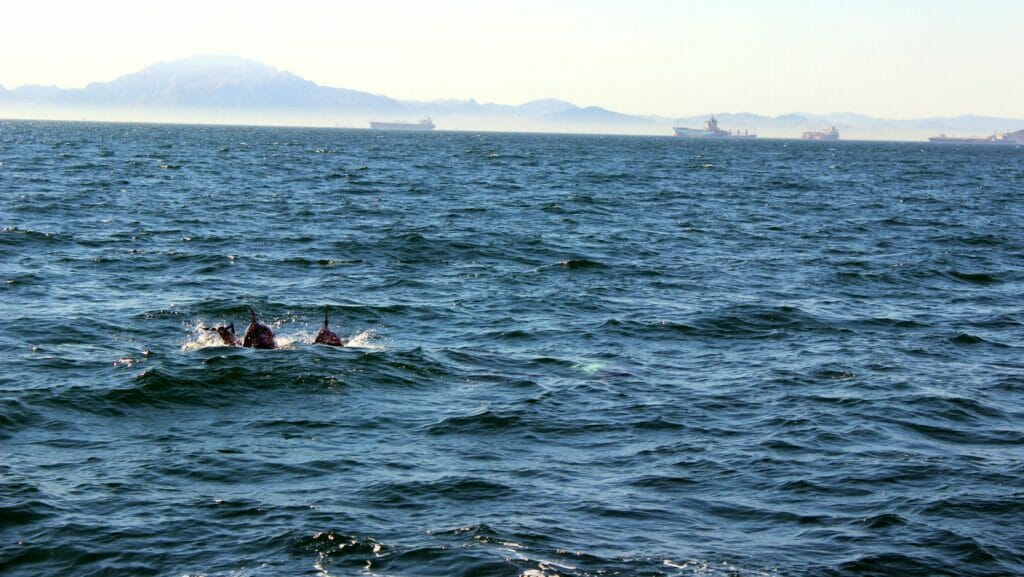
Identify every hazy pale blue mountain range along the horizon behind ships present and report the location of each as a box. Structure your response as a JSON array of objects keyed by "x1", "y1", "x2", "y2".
[{"x1": 0, "y1": 56, "x2": 1024, "y2": 139}]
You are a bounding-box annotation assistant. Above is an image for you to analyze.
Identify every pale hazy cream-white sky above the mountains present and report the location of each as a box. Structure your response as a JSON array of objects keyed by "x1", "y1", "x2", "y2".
[{"x1": 0, "y1": 0, "x2": 1024, "y2": 118}]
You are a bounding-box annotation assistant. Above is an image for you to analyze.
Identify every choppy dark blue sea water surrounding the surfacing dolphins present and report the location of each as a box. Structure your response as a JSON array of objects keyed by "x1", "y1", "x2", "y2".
[{"x1": 0, "y1": 122, "x2": 1024, "y2": 577}]
